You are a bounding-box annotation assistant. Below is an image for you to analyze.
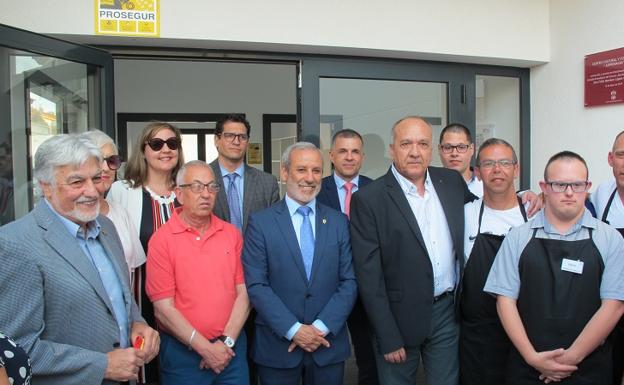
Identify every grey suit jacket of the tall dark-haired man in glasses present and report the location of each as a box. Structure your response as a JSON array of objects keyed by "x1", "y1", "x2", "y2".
[{"x1": 210, "y1": 159, "x2": 279, "y2": 234}]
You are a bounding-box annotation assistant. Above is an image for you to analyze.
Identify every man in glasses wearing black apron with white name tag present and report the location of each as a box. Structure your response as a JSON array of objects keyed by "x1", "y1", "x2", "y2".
[{"x1": 484, "y1": 151, "x2": 624, "y2": 385}]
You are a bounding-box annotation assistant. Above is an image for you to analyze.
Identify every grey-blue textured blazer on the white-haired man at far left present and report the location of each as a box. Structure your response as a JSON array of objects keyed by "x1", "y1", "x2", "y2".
[{"x1": 0, "y1": 202, "x2": 145, "y2": 385}]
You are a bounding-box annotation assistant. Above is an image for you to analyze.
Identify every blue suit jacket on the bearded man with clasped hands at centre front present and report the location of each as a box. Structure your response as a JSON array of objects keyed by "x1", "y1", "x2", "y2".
[{"x1": 242, "y1": 200, "x2": 357, "y2": 368}]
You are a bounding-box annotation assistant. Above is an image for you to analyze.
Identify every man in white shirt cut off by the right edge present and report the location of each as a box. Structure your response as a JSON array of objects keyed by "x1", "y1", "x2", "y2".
[{"x1": 590, "y1": 131, "x2": 624, "y2": 385}]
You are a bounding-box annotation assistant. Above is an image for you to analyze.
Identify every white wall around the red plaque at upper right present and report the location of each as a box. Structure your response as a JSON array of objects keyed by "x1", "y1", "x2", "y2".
[{"x1": 531, "y1": 0, "x2": 624, "y2": 190}]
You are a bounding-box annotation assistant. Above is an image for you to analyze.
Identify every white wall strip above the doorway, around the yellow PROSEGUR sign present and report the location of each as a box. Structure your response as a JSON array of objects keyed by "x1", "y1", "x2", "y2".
[{"x1": 0, "y1": 0, "x2": 549, "y2": 66}]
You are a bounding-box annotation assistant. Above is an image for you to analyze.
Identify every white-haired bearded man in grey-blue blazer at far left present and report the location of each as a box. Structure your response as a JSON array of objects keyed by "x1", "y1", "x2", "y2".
[{"x1": 0, "y1": 135, "x2": 160, "y2": 385}]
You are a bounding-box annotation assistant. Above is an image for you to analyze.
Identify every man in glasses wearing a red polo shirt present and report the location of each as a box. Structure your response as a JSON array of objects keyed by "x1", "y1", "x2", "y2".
[{"x1": 145, "y1": 160, "x2": 250, "y2": 385}]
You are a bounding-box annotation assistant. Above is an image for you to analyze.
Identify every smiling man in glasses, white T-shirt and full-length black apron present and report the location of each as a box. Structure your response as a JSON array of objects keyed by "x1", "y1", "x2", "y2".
[{"x1": 459, "y1": 138, "x2": 527, "y2": 385}]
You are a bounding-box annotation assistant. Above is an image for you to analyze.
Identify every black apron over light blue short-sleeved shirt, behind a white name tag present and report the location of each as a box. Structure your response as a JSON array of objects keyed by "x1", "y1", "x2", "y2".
[{"x1": 506, "y1": 229, "x2": 612, "y2": 385}]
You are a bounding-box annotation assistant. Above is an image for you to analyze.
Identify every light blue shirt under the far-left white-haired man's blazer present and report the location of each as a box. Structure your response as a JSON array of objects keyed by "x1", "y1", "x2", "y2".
[{"x1": 43, "y1": 199, "x2": 130, "y2": 348}]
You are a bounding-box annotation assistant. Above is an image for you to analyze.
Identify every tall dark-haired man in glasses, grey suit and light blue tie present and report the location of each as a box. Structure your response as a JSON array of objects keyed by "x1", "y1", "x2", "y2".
[{"x1": 210, "y1": 114, "x2": 279, "y2": 233}]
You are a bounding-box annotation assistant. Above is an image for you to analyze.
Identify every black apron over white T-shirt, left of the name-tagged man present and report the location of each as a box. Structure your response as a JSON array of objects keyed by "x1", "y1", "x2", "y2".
[{"x1": 459, "y1": 199, "x2": 527, "y2": 385}]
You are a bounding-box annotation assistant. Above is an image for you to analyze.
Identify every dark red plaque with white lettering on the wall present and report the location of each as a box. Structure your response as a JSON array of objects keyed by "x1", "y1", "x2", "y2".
[{"x1": 585, "y1": 48, "x2": 624, "y2": 107}]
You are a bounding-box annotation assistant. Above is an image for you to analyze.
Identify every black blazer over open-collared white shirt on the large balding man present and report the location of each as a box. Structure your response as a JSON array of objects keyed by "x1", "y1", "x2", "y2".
[{"x1": 351, "y1": 167, "x2": 475, "y2": 354}]
